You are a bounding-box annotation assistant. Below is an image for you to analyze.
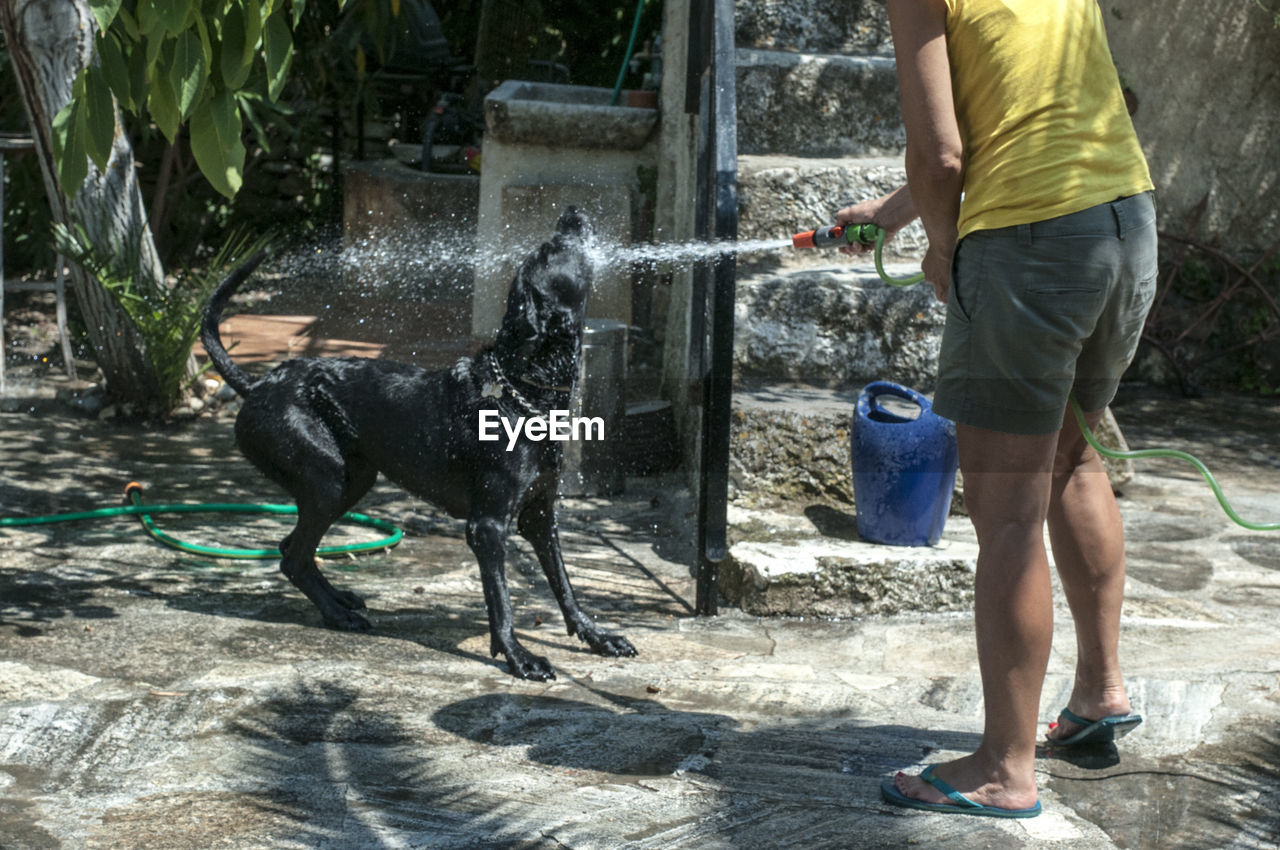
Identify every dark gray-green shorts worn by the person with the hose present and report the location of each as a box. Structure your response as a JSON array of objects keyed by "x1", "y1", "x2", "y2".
[{"x1": 933, "y1": 192, "x2": 1156, "y2": 434}]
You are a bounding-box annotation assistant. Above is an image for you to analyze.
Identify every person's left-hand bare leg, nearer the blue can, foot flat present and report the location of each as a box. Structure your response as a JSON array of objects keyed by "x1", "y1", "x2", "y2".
[{"x1": 897, "y1": 425, "x2": 1059, "y2": 809}]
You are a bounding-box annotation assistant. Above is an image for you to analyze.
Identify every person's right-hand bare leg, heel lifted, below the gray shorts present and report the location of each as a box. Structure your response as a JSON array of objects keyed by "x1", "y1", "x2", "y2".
[{"x1": 1048, "y1": 411, "x2": 1132, "y2": 740}]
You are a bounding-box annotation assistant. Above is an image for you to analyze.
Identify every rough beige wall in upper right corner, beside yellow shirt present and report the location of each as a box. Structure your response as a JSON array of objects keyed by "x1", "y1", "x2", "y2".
[{"x1": 1102, "y1": 0, "x2": 1280, "y2": 255}]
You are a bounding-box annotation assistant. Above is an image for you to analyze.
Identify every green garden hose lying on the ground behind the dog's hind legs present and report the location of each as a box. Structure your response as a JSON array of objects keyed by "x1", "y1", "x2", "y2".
[{"x1": 0, "y1": 483, "x2": 404, "y2": 559}]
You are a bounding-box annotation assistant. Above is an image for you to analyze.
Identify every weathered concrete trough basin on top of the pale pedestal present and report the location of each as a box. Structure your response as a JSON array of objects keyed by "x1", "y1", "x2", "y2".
[{"x1": 484, "y1": 79, "x2": 658, "y2": 150}]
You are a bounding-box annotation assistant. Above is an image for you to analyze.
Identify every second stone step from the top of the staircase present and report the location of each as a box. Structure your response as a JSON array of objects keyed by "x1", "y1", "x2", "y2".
[{"x1": 736, "y1": 47, "x2": 906, "y2": 156}]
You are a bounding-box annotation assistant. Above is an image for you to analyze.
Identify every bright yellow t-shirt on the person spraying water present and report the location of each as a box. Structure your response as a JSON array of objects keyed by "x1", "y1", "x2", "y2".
[{"x1": 947, "y1": 0, "x2": 1152, "y2": 237}]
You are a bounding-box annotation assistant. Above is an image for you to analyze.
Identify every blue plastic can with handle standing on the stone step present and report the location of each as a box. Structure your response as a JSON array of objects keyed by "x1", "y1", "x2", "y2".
[{"x1": 850, "y1": 380, "x2": 957, "y2": 547}]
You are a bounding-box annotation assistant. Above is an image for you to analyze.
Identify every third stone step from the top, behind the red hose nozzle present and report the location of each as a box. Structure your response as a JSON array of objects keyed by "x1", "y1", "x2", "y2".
[{"x1": 737, "y1": 154, "x2": 928, "y2": 268}]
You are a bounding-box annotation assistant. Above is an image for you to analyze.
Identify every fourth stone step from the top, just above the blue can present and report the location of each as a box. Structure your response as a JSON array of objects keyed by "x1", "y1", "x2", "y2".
[{"x1": 733, "y1": 263, "x2": 946, "y2": 392}]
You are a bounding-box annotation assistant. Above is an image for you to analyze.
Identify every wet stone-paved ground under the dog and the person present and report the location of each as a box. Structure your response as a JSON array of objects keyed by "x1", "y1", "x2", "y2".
[{"x1": 0, "y1": 373, "x2": 1280, "y2": 850}]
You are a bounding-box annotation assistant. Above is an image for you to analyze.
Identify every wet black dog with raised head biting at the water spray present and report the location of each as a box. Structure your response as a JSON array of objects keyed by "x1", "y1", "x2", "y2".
[{"x1": 201, "y1": 207, "x2": 636, "y2": 680}]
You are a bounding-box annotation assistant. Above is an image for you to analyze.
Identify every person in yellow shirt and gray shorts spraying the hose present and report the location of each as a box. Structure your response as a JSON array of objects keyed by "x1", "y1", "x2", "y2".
[{"x1": 836, "y1": 0, "x2": 1156, "y2": 817}]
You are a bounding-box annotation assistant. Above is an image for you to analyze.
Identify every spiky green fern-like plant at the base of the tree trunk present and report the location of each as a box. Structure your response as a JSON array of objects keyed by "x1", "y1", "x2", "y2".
[{"x1": 54, "y1": 224, "x2": 270, "y2": 410}]
